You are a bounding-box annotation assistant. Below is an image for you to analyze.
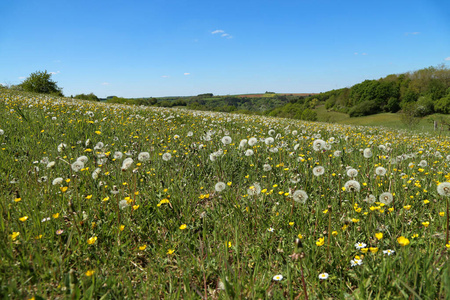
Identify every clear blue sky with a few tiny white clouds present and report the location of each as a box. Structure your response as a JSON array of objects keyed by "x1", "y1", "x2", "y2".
[{"x1": 0, "y1": 0, "x2": 450, "y2": 97}]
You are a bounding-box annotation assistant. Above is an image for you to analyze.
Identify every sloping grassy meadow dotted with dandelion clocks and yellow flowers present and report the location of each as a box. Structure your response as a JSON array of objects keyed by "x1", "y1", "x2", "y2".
[{"x1": 0, "y1": 91, "x2": 450, "y2": 299}]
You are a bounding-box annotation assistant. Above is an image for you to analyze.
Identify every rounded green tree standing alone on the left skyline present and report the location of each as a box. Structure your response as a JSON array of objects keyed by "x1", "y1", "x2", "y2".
[{"x1": 20, "y1": 70, "x2": 64, "y2": 96}]
